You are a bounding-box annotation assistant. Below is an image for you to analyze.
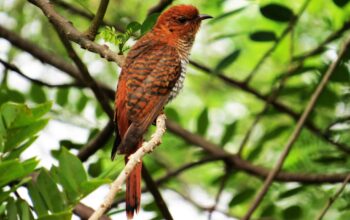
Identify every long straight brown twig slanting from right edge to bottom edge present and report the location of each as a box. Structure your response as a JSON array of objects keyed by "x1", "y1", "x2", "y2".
[{"x1": 243, "y1": 38, "x2": 350, "y2": 220}]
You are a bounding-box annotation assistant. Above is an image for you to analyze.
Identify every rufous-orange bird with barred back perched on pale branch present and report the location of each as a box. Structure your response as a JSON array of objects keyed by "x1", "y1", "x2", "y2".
[{"x1": 111, "y1": 5, "x2": 212, "y2": 219}]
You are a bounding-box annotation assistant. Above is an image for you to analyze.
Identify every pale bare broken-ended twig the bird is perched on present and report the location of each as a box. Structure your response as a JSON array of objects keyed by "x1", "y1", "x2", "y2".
[{"x1": 89, "y1": 114, "x2": 166, "y2": 220}]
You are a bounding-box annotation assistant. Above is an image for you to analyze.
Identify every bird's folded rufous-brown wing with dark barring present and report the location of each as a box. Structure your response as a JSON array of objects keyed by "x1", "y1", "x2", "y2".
[{"x1": 120, "y1": 43, "x2": 181, "y2": 152}]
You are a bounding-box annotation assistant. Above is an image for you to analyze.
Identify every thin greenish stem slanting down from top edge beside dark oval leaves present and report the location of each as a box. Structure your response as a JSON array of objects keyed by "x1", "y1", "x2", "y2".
[{"x1": 244, "y1": 0, "x2": 311, "y2": 84}]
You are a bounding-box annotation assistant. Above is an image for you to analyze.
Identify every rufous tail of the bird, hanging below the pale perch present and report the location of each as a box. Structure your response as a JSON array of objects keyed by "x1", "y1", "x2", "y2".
[{"x1": 125, "y1": 141, "x2": 142, "y2": 219}]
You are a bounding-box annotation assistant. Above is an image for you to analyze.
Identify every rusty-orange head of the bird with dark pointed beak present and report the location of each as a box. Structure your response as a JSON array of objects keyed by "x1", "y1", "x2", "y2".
[{"x1": 154, "y1": 5, "x2": 212, "y2": 44}]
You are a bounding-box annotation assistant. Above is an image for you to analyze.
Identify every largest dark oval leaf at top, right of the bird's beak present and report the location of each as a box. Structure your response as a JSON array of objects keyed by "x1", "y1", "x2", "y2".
[{"x1": 260, "y1": 3, "x2": 294, "y2": 22}]
